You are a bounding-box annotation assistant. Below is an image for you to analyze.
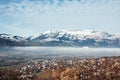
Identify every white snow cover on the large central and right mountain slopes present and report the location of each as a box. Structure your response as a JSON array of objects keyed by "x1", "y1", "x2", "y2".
[{"x1": 34, "y1": 30, "x2": 116, "y2": 41}]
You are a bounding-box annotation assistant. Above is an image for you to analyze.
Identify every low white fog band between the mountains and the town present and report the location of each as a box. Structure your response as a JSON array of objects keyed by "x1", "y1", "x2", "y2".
[{"x1": 0, "y1": 47, "x2": 120, "y2": 57}]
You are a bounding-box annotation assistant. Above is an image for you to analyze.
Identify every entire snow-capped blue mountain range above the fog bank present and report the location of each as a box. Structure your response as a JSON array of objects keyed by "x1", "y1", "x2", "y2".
[{"x1": 0, "y1": 30, "x2": 120, "y2": 48}]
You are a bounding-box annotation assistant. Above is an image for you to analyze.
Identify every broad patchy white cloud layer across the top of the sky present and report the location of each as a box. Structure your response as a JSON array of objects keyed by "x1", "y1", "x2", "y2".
[{"x1": 0, "y1": 0, "x2": 120, "y2": 17}]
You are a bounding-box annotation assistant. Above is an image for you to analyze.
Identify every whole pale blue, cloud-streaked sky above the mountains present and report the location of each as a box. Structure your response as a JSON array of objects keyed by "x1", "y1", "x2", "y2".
[{"x1": 0, "y1": 0, "x2": 120, "y2": 35}]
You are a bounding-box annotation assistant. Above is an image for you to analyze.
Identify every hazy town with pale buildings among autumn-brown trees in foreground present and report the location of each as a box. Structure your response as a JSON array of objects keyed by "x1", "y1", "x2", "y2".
[{"x1": 0, "y1": 56, "x2": 120, "y2": 80}]
